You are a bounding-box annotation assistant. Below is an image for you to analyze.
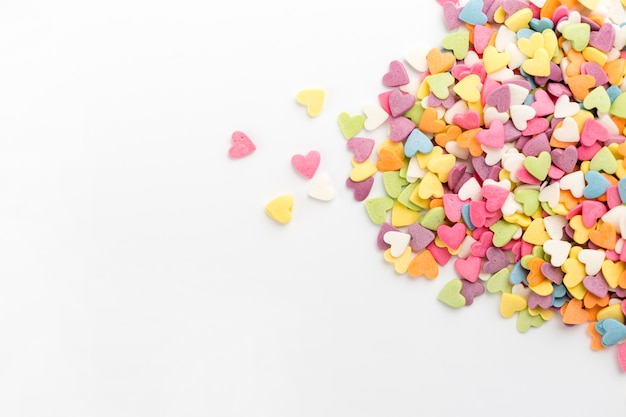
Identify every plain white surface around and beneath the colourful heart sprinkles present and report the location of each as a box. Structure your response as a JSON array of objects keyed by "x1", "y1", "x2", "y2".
[{"x1": 0, "y1": 0, "x2": 626, "y2": 417}]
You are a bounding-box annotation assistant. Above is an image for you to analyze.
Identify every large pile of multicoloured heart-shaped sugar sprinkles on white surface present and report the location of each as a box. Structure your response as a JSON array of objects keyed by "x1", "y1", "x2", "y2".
[{"x1": 338, "y1": 0, "x2": 626, "y2": 370}]
